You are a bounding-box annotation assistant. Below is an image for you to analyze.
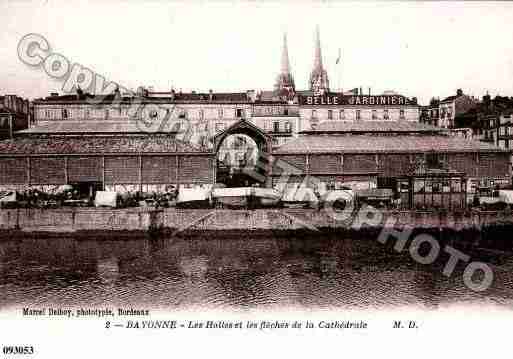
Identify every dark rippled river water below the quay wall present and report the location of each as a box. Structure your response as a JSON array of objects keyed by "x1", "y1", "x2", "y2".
[{"x1": 0, "y1": 236, "x2": 513, "y2": 309}]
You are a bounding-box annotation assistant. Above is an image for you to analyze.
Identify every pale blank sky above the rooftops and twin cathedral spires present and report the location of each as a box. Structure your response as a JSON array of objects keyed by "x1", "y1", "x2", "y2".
[{"x1": 0, "y1": 0, "x2": 513, "y2": 104}]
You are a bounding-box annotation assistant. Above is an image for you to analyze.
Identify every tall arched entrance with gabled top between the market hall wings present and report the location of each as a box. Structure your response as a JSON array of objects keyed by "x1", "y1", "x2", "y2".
[{"x1": 214, "y1": 120, "x2": 272, "y2": 187}]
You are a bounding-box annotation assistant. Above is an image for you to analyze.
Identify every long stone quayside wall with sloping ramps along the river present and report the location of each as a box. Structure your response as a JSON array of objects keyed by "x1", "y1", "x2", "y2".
[{"x1": 0, "y1": 208, "x2": 513, "y2": 239}]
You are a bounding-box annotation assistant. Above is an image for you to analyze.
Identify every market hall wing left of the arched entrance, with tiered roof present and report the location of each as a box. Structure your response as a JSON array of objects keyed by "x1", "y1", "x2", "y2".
[{"x1": 0, "y1": 121, "x2": 214, "y2": 195}]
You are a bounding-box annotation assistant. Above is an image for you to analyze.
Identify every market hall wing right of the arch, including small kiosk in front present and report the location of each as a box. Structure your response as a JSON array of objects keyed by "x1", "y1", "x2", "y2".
[{"x1": 271, "y1": 121, "x2": 511, "y2": 208}]
